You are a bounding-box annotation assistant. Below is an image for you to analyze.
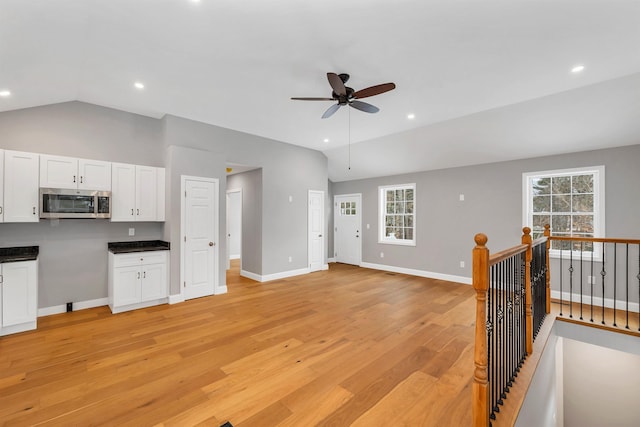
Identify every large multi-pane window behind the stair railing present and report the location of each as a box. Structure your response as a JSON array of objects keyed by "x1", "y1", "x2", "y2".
[{"x1": 522, "y1": 166, "x2": 604, "y2": 255}]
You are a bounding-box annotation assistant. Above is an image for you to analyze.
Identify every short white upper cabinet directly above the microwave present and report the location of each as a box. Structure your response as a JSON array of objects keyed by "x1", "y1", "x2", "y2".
[{"x1": 40, "y1": 154, "x2": 111, "y2": 191}]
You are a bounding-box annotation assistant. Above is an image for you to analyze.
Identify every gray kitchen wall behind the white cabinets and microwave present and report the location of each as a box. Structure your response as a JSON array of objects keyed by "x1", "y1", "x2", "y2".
[{"x1": 0, "y1": 102, "x2": 164, "y2": 308}]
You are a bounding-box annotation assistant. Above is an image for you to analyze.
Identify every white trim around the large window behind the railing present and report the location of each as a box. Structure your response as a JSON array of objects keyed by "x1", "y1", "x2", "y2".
[{"x1": 522, "y1": 165, "x2": 606, "y2": 261}]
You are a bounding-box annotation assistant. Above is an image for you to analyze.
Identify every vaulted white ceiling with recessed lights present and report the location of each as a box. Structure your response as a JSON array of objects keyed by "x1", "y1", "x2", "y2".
[{"x1": 0, "y1": 0, "x2": 640, "y2": 181}]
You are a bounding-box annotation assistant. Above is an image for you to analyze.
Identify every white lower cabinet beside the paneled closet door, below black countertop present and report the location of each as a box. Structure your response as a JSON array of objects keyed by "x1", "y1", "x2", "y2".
[{"x1": 109, "y1": 251, "x2": 169, "y2": 313}]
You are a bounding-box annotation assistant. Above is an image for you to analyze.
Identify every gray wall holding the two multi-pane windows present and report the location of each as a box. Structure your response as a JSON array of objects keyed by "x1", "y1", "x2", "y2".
[{"x1": 329, "y1": 145, "x2": 640, "y2": 277}]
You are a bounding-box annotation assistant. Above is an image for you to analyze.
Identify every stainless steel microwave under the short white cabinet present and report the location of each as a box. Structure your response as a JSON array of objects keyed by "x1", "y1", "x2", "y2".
[{"x1": 40, "y1": 188, "x2": 111, "y2": 218}]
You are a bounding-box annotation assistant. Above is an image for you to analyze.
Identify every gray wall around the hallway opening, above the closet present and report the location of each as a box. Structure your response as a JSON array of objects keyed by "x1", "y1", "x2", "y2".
[{"x1": 164, "y1": 116, "x2": 328, "y2": 283}]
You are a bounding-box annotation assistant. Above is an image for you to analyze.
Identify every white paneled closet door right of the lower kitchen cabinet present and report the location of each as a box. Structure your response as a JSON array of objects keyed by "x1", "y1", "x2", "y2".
[{"x1": 182, "y1": 176, "x2": 219, "y2": 299}]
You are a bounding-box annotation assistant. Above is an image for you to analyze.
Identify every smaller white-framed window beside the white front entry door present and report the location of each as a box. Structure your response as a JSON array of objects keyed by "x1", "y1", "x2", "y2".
[{"x1": 378, "y1": 184, "x2": 416, "y2": 246}]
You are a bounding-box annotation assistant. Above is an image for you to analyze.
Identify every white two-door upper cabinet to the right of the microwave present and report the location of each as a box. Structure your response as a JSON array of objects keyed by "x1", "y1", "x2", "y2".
[{"x1": 111, "y1": 163, "x2": 165, "y2": 221}]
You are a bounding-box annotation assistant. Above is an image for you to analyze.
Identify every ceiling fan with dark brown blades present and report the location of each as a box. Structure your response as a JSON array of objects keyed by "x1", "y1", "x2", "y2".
[{"x1": 291, "y1": 73, "x2": 396, "y2": 119}]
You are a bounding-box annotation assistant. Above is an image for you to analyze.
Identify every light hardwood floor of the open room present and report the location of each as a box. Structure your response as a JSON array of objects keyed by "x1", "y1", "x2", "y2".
[{"x1": 0, "y1": 263, "x2": 475, "y2": 427}]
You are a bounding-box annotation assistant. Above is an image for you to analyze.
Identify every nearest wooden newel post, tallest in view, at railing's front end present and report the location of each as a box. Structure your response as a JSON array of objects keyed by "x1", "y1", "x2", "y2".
[{"x1": 471, "y1": 234, "x2": 489, "y2": 427}]
